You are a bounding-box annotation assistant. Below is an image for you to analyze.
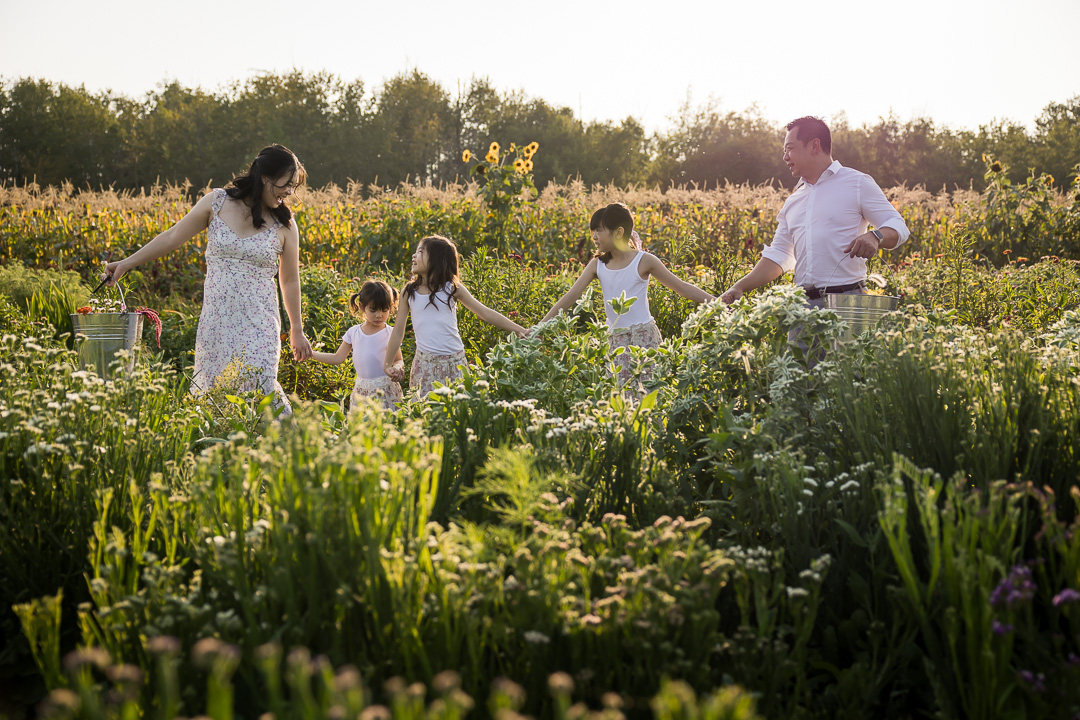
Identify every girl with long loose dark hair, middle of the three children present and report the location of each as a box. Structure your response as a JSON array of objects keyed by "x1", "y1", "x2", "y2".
[{"x1": 383, "y1": 235, "x2": 525, "y2": 397}]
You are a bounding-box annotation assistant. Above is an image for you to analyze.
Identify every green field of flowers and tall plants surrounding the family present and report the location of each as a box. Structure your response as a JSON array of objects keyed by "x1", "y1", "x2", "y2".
[{"x1": 0, "y1": 165, "x2": 1080, "y2": 719}]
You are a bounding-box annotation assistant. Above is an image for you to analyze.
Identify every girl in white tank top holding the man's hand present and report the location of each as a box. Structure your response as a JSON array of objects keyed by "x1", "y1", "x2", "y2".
[{"x1": 541, "y1": 203, "x2": 715, "y2": 383}]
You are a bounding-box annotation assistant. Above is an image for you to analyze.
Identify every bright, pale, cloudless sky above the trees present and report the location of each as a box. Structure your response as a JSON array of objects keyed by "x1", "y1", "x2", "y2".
[{"x1": 0, "y1": 0, "x2": 1080, "y2": 131}]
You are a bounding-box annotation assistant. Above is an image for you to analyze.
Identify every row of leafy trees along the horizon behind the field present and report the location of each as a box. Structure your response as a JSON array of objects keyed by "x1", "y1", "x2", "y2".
[{"x1": 0, "y1": 70, "x2": 1080, "y2": 191}]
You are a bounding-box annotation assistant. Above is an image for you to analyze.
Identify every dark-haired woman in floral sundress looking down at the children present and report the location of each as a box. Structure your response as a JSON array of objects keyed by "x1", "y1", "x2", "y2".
[{"x1": 105, "y1": 145, "x2": 311, "y2": 413}]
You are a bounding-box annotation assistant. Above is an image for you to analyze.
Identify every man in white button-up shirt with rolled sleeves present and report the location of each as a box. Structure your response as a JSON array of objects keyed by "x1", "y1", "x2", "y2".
[{"x1": 720, "y1": 118, "x2": 910, "y2": 306}]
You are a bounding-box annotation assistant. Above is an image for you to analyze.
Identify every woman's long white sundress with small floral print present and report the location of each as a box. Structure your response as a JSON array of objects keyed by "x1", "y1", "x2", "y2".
[{"x1": 191, "y1": 188, "x2": 293, "y2": 415}]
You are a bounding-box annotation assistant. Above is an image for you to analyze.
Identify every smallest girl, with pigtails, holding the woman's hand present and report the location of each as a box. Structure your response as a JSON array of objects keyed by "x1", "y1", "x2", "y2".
[{"x1": 311, "y1": 280, "x2": 404, "y2": 410}]
